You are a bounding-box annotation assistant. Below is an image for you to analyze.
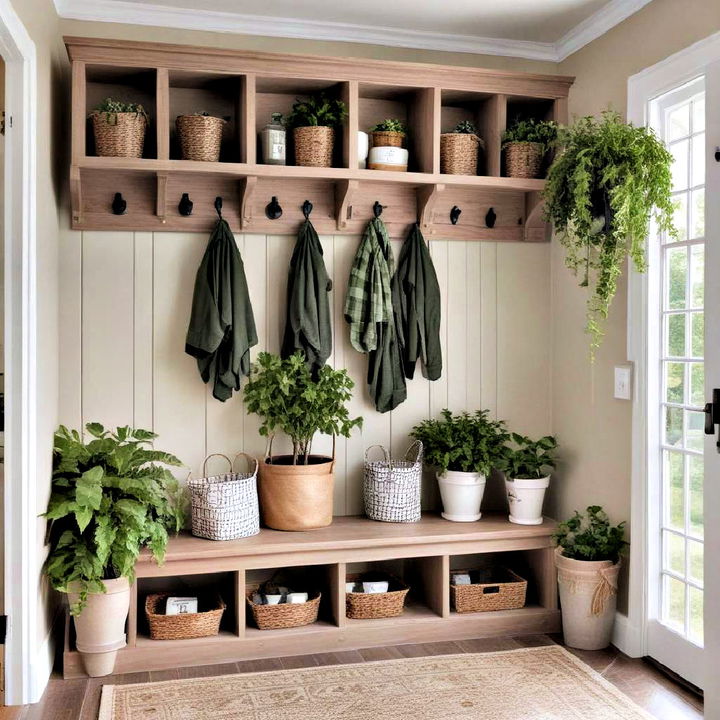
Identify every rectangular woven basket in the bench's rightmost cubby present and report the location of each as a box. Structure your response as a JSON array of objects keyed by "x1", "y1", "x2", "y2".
[{"x1": 450, "y1": 568, "x2": 527, "y2": 613}]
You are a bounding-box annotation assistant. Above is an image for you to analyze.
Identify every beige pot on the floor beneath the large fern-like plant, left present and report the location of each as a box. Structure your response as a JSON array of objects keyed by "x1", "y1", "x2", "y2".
[{"x1": 68, "y1": 578, "x2": 130, "y2": 677}]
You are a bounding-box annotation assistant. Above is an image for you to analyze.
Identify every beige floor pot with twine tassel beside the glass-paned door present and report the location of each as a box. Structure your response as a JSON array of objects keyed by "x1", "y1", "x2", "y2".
[{"x1": 555, "y1": 548, "x2": 620, "y2": 650}]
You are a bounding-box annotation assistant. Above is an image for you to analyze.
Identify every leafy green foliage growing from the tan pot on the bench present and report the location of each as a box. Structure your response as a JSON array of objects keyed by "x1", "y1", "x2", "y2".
[{"x1": 244, "y1": 351, "x2": 362, "y2": 465}]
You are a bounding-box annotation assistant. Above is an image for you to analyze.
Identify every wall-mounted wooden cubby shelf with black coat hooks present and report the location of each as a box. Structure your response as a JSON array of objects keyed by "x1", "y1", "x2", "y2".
[{"x1": 65, "y1": 38, "x2": 573, "y2": 242}]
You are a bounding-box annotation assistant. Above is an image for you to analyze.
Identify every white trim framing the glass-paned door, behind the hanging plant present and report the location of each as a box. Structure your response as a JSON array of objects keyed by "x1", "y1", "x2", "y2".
[{"x1": 624, "y1": 28, "x2": 720, "y2": 668}]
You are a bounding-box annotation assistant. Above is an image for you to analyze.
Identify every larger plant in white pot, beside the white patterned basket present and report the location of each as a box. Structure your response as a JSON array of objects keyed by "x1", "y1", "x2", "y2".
[{"x1": 410, "y1": 409, "x2": 509, "y2": 522}]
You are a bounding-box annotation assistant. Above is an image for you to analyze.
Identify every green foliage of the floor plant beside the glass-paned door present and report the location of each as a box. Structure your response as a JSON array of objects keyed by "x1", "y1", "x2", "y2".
[{"x1": 553, "y1": 505, "x2": 628, "y2": 563}]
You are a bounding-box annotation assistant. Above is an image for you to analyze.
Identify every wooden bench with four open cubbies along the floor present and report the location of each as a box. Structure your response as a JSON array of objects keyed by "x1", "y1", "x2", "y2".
[{"x1": 63, "y1": 515, "x2": 560, "y2": 678}]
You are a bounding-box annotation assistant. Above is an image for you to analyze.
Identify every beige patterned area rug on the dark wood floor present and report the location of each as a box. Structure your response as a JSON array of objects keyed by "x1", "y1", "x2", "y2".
[{"x1": 99, "y1": 646, "x2": 651, "y2": 720}]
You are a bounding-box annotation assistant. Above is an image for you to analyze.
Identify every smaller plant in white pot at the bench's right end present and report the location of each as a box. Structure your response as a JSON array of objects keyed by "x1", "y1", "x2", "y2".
[{"x1": 498, "y1": 433, "x2": 557, "y2": 525}]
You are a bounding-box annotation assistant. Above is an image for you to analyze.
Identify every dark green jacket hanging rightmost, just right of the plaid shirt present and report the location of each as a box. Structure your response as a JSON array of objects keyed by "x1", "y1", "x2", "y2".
[{"x1": 395, "y1": 225, "x2": 442, "y2": 380}]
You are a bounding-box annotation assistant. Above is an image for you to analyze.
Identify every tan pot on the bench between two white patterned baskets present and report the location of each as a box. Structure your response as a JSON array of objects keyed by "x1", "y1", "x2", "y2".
[{"x1": 258, "y1": 455, "x2": 335, "y2": 530}]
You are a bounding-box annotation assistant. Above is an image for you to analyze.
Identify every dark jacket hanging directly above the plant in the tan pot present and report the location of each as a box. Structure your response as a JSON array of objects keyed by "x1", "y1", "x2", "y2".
[{"x1": 281, "y1": 220, "x2": 332, "y2": 374}]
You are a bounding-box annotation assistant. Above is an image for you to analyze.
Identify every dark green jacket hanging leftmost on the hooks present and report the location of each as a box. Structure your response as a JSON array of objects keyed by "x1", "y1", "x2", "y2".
[{"x1": 185, "y1": 220, "x2": 257, "y2": 401}]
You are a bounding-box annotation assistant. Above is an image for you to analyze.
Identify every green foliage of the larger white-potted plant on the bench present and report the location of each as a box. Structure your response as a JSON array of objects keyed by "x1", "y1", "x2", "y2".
[{"x1": 410, "y1": 409, "x2": 510, "y2": 475}]
